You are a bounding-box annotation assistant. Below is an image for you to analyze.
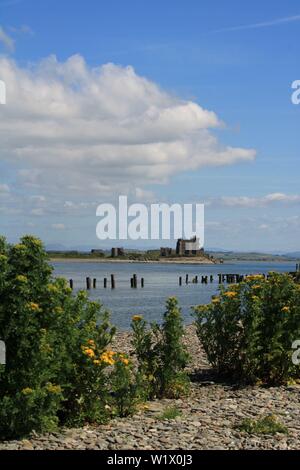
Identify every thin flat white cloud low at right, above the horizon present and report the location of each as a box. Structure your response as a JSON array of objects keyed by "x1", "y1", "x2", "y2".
[{"x1": 206, "y1": 193, "x2": 300, "y2": 208}]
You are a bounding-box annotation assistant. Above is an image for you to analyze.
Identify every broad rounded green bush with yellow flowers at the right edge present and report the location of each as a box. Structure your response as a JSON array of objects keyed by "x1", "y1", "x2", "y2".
[{"x1": 195, "y1": 273, "x2": 300, "y2": 384}]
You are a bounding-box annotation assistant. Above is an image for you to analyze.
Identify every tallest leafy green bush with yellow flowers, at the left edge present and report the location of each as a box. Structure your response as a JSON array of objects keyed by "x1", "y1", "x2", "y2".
[{"x1": 0, "y1": 236, "x2": 115, "y2": 438}]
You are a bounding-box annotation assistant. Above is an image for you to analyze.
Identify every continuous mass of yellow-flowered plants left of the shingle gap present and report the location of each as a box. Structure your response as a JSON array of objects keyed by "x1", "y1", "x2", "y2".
[{"x1": 0, "y1": 236, "x2": 185, "y2": 438}]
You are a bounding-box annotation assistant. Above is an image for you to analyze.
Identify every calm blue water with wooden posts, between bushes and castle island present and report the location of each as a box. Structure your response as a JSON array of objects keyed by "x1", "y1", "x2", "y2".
[{"x1": 53, "y1": 261, "x2": 295, "y2": 329}]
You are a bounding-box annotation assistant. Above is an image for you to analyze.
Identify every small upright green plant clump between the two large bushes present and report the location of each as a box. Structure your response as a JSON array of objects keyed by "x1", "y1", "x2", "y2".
[{"x1": 131, "y1": 298, "x2": 189, "y2": 398}]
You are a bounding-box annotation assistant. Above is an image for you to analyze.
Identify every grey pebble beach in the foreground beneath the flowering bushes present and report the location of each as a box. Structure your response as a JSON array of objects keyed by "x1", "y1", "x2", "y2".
[{"x1": 0, "y1": 325, "x2": 300, "y2": 450}]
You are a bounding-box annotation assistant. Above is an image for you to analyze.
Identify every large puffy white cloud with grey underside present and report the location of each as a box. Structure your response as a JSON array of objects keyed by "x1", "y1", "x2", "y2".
[{"x1": 0, "y1": 55, "x2": 255, "y2": 198}]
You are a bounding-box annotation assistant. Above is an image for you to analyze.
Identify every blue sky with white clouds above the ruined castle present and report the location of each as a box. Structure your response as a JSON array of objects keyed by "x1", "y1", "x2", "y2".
[{"x1": 0, "y1": 0, "x2": 300, "y2": 252}]
